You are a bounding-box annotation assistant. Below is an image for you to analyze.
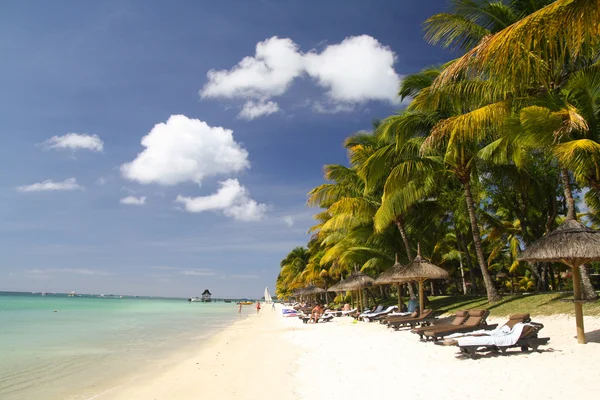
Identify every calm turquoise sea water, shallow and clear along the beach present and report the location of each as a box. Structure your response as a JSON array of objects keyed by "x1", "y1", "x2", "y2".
[{"x1": 0, "y1": 293, "x2": 246, "y2": 400}]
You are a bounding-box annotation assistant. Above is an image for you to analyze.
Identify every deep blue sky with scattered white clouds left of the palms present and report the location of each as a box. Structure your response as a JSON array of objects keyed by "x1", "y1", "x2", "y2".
[{"x1": 0, "y1": 0, "x2": 451, "y2": 297}]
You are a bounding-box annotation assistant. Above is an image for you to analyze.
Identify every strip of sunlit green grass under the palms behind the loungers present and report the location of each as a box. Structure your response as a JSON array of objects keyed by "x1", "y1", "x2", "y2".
[{"x1": 427, "y1": 293, "x2": 600, "y2": 317}]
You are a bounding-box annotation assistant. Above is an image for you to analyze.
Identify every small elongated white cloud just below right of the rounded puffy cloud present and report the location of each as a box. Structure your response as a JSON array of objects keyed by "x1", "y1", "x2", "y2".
[{"x1": 175, "y1": 179, "x2": 267, "y2": 221}]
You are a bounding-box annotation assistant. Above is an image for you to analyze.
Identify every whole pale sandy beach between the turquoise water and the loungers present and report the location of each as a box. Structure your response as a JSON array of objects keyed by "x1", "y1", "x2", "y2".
[{"x1": 102, "y1": 307, "x2": 600, "y2": 400}]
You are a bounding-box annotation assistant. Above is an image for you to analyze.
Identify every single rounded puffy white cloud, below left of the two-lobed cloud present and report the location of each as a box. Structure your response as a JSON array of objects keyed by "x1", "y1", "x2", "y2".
[{"x1": 121, "y1": 115, "x2": 250, "y2": 185}]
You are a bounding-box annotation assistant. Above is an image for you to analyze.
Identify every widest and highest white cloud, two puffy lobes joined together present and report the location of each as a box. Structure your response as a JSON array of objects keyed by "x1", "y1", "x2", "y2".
[{"x1": 200, "y1": 35, "x2": 401, "y2": 119}]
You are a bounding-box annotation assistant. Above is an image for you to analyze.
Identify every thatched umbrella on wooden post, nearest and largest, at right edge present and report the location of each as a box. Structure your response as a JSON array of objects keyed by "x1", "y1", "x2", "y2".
[{"x1": 519, "y1": 218, "x2": 600, "y2": 344}]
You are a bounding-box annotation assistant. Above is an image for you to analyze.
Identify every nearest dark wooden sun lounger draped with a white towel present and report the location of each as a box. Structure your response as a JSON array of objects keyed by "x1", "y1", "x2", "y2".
[{"x1": 444, "y1": 322, "x2": 550, "y2": 359}]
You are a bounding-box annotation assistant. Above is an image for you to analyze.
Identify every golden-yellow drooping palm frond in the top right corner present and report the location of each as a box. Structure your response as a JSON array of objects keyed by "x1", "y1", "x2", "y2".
[{"x1": 434, "y1": 0, "x2": 600, "y2": 93}]
